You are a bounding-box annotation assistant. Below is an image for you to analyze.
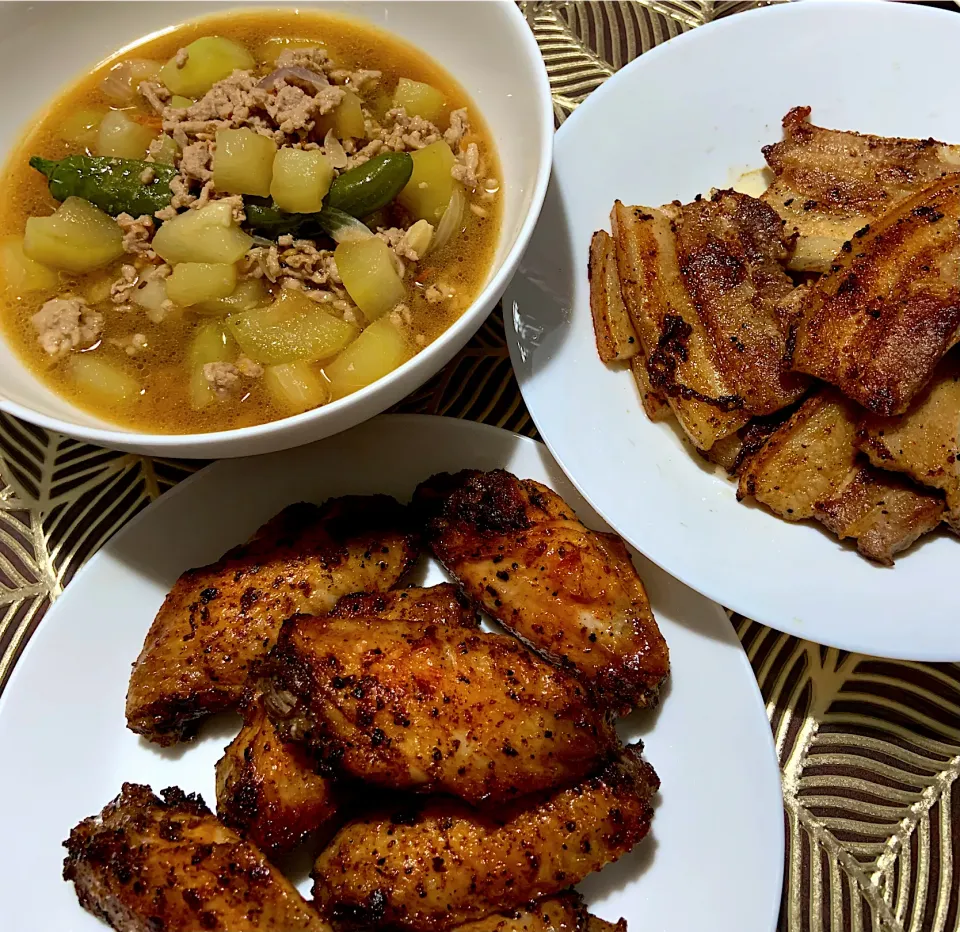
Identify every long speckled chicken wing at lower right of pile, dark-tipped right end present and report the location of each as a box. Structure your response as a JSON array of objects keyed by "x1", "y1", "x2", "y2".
[{"x1": 313, "y1": 747, "x2": 659, "y2": 932}]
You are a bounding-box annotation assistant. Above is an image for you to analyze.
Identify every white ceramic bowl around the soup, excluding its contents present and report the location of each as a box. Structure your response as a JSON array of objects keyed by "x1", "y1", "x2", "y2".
[{"x1": 0, "y1": 0, "x2": 553, "y2": 458}]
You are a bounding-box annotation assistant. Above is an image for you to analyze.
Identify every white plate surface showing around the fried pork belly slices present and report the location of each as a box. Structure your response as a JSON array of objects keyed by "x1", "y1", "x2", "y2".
[{"x1": 504, "y1": 2, "x2": 960, "y2": 660}]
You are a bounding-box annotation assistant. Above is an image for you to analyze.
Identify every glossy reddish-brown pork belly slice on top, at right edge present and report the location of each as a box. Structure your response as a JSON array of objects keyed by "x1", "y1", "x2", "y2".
[{"x1": 791, "y1": 175, "x2": 960, "y2": 416}]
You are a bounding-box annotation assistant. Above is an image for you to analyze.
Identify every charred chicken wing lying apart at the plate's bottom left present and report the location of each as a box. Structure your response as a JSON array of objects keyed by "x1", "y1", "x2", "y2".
[{"x1": 63, "y1": 783, "x2": 331, "y2": 932}]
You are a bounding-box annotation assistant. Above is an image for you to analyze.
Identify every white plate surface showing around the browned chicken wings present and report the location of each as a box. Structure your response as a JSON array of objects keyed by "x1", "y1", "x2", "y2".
[{"x1": 0, "y1": 416, "x2": 783, "y2": 932}]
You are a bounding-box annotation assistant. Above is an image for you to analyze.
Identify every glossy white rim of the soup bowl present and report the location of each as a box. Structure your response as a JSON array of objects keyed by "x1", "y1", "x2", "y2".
[{"x1": 0, "y1": 0, "x2": 555, "y2": 458}]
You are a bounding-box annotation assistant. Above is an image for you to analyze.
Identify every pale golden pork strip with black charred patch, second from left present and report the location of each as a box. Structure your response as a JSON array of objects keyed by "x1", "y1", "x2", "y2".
[{"x1": 610, "y1": 201, "x2": 750, "y2": 450}]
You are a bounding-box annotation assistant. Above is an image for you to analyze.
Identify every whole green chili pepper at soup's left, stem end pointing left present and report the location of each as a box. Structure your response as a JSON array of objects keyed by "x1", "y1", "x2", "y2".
[{"x1": 30, "y1": 155, "x2": 177, "y2": 217}]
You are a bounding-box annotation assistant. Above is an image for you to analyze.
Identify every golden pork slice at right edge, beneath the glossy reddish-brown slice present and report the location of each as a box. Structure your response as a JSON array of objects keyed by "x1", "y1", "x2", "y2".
[{"x1": 858, "y1": 353, "x2": 960, "y2": 533}]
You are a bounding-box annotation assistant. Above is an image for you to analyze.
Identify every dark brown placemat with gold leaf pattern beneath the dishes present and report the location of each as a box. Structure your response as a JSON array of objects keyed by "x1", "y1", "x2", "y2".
[{"x1": 0, "y1": 0, "x2": 960, "y2": 932}]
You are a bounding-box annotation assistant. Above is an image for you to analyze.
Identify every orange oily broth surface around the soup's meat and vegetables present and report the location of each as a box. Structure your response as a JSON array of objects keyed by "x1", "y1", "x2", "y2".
[{"x1": 0, "y1": 10, "x2": 502, "y2": 433}]
